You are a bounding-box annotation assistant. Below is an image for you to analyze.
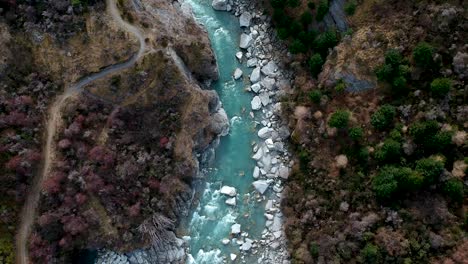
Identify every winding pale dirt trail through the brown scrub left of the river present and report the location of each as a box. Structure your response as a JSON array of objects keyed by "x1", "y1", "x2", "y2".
[{"x1": 16, "y1": 0, "x2": 146, "y2": 264}]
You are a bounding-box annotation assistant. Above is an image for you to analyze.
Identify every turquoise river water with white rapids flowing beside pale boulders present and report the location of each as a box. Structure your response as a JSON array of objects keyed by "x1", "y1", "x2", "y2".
[{"x1": 186, "y1": 0, "x2": 265, "y2": 264}]
